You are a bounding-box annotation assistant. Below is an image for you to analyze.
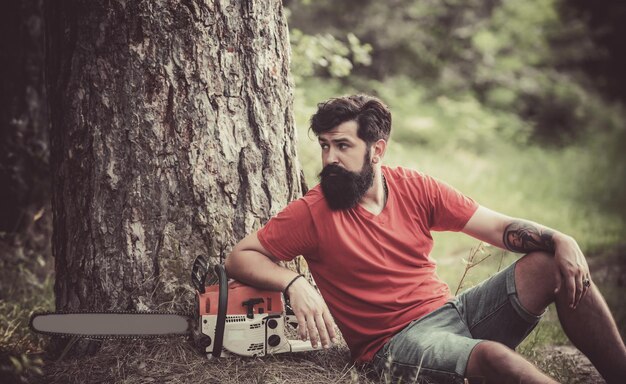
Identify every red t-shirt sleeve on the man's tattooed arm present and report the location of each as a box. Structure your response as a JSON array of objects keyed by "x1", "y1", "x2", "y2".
[{"x1": 426, "y1": 177, "x2": 478, "y2": 231}]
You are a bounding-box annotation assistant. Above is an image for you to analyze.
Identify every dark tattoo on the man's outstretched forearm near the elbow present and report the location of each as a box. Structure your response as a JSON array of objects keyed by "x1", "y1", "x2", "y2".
[{"x1": 502, "y1": 220, "x2": 554, "y2": 253}]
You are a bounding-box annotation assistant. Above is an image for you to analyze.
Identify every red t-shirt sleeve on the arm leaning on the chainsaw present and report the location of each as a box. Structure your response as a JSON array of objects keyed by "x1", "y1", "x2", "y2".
[{"x1": 257, "y1": 199, "x2": 317, "y2": 261}]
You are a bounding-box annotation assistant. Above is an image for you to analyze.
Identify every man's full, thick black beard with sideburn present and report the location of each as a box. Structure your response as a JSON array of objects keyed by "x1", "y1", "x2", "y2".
[{"x1": 319, "y1": 150, "x2": 374, "y2": 211}]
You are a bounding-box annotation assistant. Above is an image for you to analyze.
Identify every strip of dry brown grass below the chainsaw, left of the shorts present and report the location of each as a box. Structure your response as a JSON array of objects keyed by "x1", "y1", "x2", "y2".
[{"x1": 29, "y1": 339, "x2": 378, "y2": 384}]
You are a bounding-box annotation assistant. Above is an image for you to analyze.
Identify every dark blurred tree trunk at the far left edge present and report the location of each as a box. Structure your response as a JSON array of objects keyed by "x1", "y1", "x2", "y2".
[{"x1": 0, "y1": 0, "x2": 50, "y2": 234}]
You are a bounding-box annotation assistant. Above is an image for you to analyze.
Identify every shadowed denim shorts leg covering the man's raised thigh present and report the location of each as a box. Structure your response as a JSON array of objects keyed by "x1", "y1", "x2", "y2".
[{"x1": 452, "y1": 263, "x2": 542, "y2": 349}]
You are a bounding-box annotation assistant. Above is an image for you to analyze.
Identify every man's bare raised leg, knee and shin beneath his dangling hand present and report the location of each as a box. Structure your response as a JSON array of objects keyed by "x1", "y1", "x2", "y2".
[{"x1": 512, "y1": 252, "x2": 626, "y2": 383}]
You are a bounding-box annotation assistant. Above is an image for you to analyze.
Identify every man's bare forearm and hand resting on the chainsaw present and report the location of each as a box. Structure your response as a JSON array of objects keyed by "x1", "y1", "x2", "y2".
[{"x1": 225, "y1": 232, "x2": 337, "y2": 348}]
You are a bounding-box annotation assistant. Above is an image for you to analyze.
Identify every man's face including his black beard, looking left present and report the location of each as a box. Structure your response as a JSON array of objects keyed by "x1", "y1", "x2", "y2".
[{"x1": 319, "y1": 121, "x2": 374, "y2": 210}]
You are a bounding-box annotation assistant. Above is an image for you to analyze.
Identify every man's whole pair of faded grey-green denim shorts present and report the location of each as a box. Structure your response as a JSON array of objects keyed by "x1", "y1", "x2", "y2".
[{"x1": 372, "y1": 263, "x2": 542, "y2": 384}]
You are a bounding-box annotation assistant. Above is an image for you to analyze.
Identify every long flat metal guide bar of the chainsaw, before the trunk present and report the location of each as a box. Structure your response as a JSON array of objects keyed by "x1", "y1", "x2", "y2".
[{"x1": 29, "y1": 311, "x2": 193, "y2": 339}]
